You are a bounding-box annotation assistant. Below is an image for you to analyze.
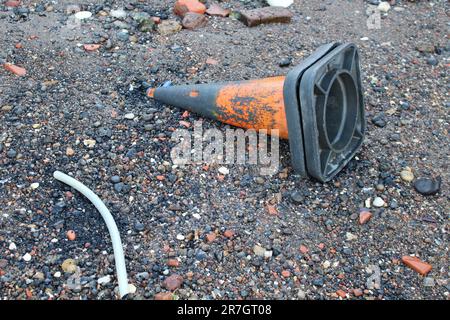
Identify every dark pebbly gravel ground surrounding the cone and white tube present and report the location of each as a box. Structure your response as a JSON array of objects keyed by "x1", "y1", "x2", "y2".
[{"x1": 0, "y1": 0, "x2": 449, "y2": 300}]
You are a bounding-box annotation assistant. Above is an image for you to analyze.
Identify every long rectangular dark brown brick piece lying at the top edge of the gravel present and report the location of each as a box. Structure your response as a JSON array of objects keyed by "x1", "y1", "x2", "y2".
[{"x1": 240, "y1": 7, "x2": 293, "y2": 27}]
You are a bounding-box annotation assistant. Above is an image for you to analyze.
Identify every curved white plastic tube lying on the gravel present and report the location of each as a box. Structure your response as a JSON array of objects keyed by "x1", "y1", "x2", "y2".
[{"x1": 53, "y1": 171, "x2": 128, "y2": 298}]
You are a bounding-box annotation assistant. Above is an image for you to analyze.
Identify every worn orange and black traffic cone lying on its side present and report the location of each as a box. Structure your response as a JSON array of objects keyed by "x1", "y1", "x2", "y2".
[{"x1": 147, "y1": 43, "x2": 366, "y2": 182}]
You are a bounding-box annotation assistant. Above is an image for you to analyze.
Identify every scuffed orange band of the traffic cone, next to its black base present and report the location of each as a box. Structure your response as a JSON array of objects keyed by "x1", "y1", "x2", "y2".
[{"x1": 216, "y1": 77, "x2": 288, "y2": 139}]
